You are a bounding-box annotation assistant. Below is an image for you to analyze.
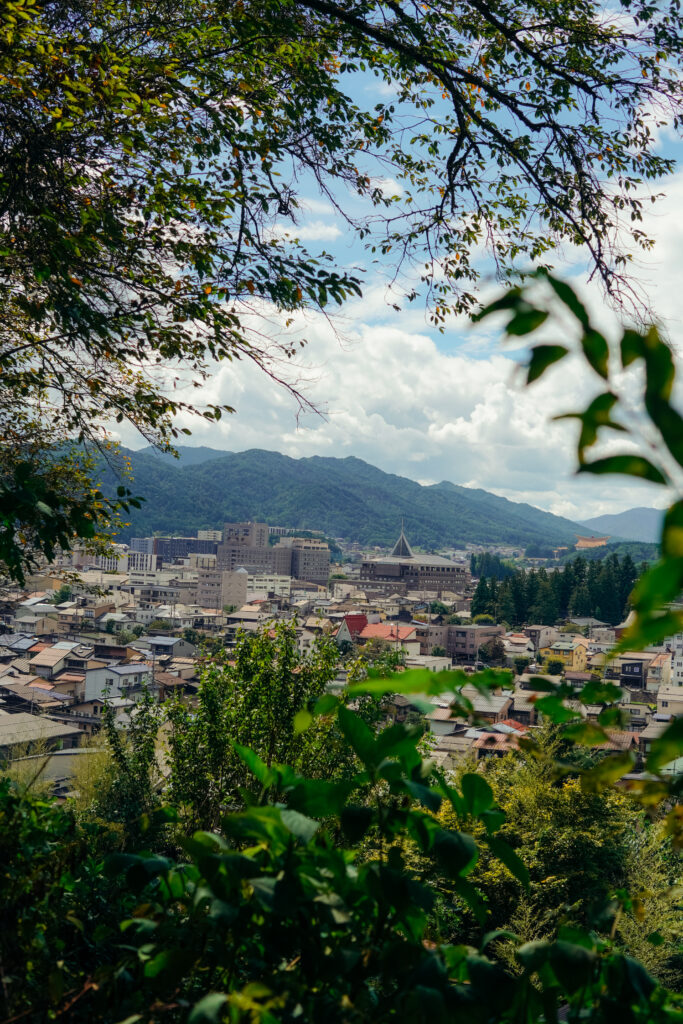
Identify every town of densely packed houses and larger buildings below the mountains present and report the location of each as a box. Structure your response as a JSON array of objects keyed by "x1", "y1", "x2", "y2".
[{"x1": 0, "y1": 522, "x2": 683, "y2": 796}]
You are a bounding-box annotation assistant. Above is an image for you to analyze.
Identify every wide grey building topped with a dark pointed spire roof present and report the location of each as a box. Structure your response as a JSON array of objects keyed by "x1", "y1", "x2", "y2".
[{"x1": 358, "y1": 529, "x2": 470, "y2": 596}]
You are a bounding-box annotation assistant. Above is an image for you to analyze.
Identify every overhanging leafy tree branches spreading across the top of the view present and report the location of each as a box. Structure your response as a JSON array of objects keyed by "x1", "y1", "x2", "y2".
[{"x1": 5, "y1": 0, "x2": 682, "y2": 579}]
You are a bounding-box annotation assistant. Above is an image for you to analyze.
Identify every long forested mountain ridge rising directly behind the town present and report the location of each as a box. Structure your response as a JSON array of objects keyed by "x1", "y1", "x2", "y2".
[{"x1": 103, "y1": 447, "x2": 584, "y2": 550}]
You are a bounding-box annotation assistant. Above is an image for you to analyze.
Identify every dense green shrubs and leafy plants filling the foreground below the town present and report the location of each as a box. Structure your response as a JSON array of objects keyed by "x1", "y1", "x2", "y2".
[{"x1": 0, "y1": 627, "x2": 683, "y2": 1024}]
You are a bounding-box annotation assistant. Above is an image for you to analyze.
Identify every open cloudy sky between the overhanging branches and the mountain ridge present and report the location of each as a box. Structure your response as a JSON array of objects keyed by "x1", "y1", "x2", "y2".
[{"x1": 121, "y1": 78, "x2": 683, "y2": 521}]
